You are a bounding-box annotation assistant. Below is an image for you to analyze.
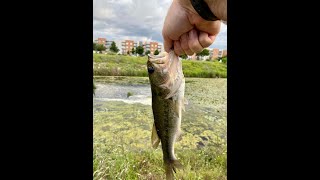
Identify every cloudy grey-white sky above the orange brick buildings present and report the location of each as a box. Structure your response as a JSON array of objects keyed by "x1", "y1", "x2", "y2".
[{"x1": 93, "y1": 0, "x2": 227, "y2": 49}]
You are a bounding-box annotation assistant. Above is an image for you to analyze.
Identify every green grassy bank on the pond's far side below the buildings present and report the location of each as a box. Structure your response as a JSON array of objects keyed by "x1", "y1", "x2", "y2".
[{"x1": 93, "y1": 54, "x2": 227, "y2": 78}]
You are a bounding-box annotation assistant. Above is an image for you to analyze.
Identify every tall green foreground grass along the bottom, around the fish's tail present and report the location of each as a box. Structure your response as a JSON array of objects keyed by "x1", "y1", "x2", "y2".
[{"x1": 93, "y1": 141, "x2": 227, "y2": 180}]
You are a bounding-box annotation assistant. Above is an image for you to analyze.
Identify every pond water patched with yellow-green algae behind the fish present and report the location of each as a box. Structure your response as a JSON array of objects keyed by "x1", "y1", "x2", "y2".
[{"x1": 93, "y1": 79, "x2": 226, "y2": 148}]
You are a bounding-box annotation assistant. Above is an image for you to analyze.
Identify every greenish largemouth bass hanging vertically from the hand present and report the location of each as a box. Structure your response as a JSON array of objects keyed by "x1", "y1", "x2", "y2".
[{"x1": 147, "y1": 50, "x2": 186, "y2": 179}]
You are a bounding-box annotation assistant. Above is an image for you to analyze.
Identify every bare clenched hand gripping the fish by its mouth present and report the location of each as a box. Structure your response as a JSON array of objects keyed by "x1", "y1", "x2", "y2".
[{"x1": 162, "y1": 0, "x2": 225, "y2": 55}]
